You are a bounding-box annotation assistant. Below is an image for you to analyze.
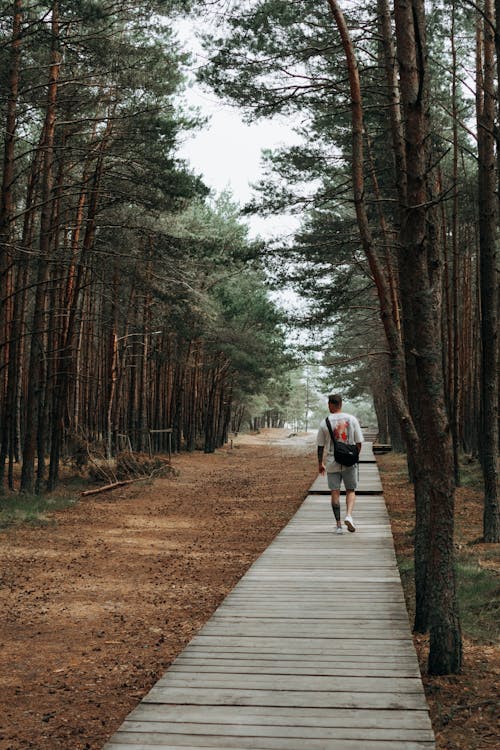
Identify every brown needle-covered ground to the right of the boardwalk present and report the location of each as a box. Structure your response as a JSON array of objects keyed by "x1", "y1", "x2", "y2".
[{"x1": 378, "y1": 453, "x2": 500, "y2": 750}]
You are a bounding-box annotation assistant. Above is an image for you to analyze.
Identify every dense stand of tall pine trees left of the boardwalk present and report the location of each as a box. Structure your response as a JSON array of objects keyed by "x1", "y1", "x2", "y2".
[{"x1": 0, "y1": 0, "x2": 288, "y2": 492}]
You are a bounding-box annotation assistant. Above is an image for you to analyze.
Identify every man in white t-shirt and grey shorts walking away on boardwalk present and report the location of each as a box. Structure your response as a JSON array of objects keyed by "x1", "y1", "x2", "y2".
[{"x1": 316, "y1": 393, "x2": 363, "y2": 534}]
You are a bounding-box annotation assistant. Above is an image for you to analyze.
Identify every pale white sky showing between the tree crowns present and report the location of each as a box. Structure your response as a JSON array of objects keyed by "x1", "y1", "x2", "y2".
[{"x1": 177, "y1": 21, "x2": 298, "y2": 238}]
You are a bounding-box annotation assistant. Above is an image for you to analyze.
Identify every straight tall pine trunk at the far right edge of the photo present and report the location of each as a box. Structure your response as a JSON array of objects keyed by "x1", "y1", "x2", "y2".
[{"x1": 477, "y1": 0, "x2": 500, "y2": 542}]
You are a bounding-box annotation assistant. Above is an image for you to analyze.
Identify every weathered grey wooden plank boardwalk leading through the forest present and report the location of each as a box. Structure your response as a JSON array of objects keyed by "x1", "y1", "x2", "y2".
[{"x1": 105, "y1": 445, "x2": 435, "y2": 750}]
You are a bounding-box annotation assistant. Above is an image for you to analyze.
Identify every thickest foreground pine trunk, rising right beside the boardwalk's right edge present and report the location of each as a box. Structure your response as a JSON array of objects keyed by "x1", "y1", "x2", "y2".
[{"x1": 395, "y1": 0, "x2": 462, "y2": 674}]
